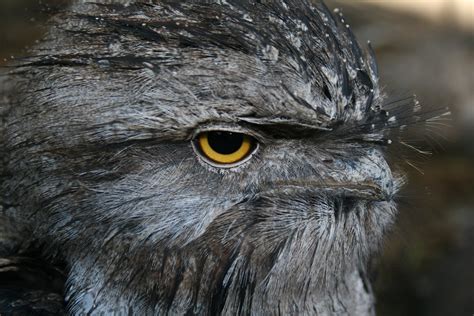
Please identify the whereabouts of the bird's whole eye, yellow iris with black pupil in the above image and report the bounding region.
[195,131,257,167]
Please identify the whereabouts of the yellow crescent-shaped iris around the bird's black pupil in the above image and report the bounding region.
[198,133,252,164]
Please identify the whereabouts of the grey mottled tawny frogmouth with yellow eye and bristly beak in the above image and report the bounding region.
[0,0,434,315]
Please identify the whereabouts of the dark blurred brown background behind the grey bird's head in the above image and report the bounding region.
[0,0,474,316]
